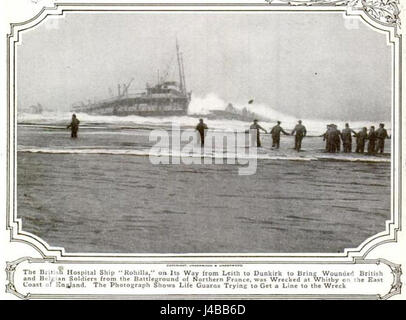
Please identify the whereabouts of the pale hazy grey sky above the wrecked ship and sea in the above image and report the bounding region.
[17,13,392,120]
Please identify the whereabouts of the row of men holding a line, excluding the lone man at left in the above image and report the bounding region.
[196,119,390,154]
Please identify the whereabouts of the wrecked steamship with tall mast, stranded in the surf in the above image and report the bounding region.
[71,43,191,116]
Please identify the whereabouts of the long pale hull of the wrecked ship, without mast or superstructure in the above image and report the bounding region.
[73,97,190,117]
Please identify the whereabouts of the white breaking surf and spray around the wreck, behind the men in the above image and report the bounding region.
[17,94,390,135]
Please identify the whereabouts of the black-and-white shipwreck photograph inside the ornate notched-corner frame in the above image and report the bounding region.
[14,9,394,254]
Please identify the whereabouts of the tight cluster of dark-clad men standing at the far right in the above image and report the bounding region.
[321,123,390,154]
